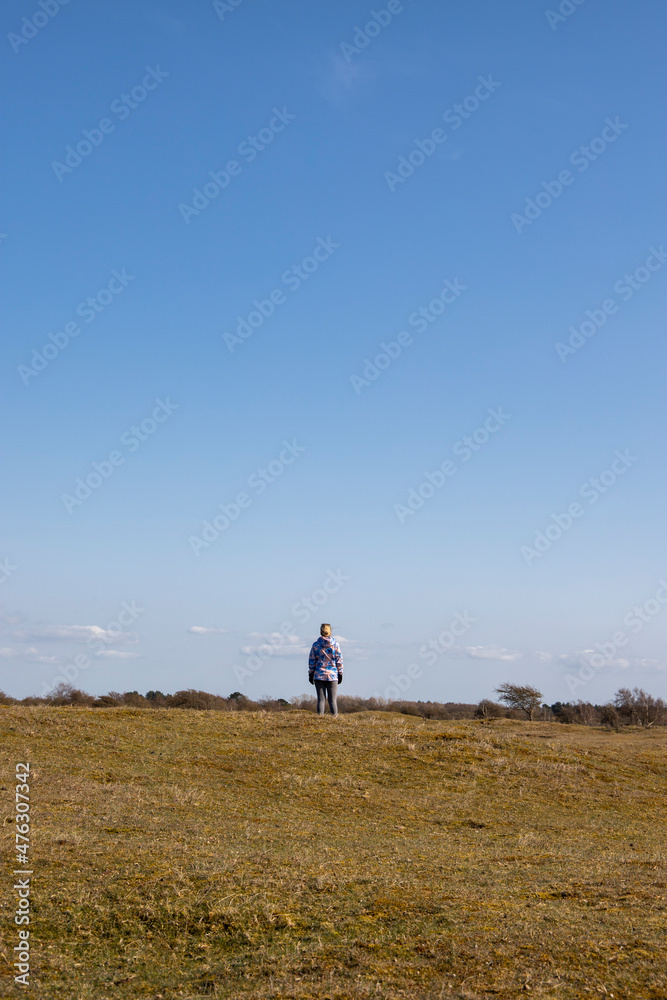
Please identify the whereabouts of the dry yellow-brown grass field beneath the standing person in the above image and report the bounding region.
[0,707,667,1000]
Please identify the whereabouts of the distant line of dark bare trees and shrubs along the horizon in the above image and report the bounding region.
[0,684,667,729]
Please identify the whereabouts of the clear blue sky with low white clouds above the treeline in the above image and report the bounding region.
[0,0,667,702]
